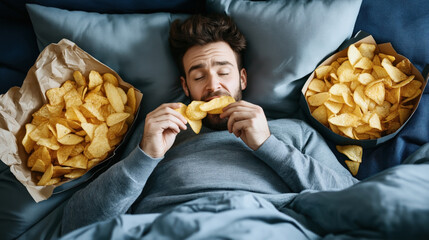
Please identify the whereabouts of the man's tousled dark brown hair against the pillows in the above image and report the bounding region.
[168,14,246,76]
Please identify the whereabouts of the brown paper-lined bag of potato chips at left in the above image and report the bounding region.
[0,39,142,202]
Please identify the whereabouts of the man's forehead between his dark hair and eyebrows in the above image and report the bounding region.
[183,42,237,71]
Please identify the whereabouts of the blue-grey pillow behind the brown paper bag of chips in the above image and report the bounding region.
[27,4,187,116]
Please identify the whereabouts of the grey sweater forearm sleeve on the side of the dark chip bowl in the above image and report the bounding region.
[254,126,358,192]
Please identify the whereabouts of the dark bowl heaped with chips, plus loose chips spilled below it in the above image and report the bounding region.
[300,31,427,175]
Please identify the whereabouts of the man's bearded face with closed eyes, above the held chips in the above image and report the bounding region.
[180,42,247,129]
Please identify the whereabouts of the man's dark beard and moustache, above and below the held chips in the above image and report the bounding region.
[187,85,242,130]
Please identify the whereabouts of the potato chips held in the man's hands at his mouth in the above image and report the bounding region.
[176,96,235,134]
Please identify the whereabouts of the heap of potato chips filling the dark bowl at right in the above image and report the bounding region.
[305,43,423,140]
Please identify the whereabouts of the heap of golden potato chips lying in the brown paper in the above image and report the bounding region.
[22,71,138,186]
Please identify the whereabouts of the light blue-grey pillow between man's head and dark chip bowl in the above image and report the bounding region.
[206,0,362,118]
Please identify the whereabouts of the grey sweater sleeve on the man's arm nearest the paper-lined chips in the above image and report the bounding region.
[62,146,161,234]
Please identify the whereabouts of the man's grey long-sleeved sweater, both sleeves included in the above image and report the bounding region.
[62,119,358,234]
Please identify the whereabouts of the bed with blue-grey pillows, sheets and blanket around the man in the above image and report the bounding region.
[0,0,429,239]
